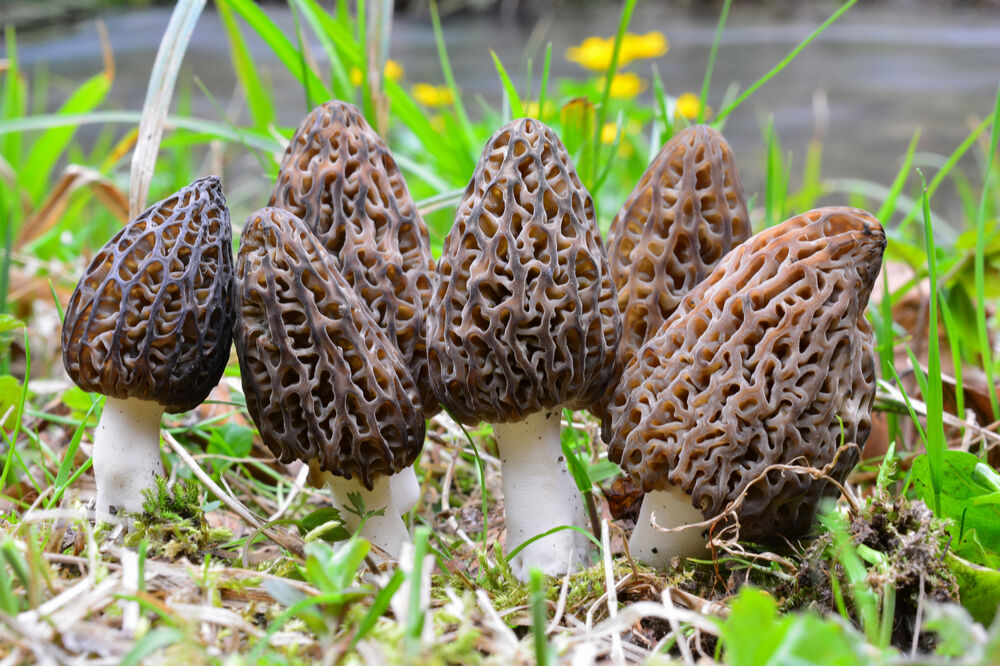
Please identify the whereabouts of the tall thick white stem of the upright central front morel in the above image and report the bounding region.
[493,410,590,581]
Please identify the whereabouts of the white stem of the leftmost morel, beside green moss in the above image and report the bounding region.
[94,396,163,524]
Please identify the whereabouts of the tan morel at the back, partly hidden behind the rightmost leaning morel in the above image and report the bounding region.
[594,125,750,441]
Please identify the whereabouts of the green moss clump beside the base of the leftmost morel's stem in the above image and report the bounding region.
[125,477,232,562]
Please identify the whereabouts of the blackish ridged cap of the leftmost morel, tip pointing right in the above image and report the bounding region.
[62,176,233,412]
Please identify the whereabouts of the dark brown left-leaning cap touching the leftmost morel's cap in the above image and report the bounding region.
[234,208,425,490]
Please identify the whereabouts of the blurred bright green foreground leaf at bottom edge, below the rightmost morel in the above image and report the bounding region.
[719,587,867,665]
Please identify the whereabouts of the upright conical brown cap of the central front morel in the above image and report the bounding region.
[428,119,621,424]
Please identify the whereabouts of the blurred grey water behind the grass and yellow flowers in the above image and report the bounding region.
[11,1,1000,232]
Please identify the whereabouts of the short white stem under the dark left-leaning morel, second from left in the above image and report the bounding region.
[323,472,410,560]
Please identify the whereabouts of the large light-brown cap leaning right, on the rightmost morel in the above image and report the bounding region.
[609,207,886,542]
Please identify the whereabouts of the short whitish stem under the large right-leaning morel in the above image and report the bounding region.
[628,486,708,570]
